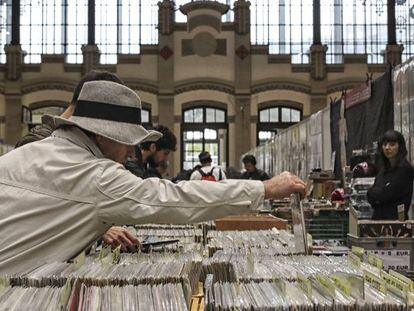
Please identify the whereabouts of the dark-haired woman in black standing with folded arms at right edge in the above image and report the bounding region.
[367,130,414,220]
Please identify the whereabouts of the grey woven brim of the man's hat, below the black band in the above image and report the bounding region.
[54,116,162,146]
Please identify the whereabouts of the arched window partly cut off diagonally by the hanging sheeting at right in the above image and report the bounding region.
[257,106,302,145]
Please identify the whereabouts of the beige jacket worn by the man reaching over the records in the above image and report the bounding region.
[0,127,264,275]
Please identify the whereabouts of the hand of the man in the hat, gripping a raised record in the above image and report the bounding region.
[263,172,306,199]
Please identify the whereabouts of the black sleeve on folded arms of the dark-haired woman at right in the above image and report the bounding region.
[367,166,413,204]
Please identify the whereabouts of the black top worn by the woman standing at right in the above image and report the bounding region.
[367,159,414,220]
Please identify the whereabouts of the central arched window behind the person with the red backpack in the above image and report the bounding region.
[181,107,228,170]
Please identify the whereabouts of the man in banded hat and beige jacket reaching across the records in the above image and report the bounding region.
[0,81,305,274]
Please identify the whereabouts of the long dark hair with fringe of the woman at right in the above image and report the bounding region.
[378,130,408,172]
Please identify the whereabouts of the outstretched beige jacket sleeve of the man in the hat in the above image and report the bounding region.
[96,161,264,225]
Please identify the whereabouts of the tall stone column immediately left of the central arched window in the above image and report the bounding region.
[158,0,174,176]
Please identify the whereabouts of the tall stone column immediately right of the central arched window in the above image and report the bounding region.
[233,0,252,167]
